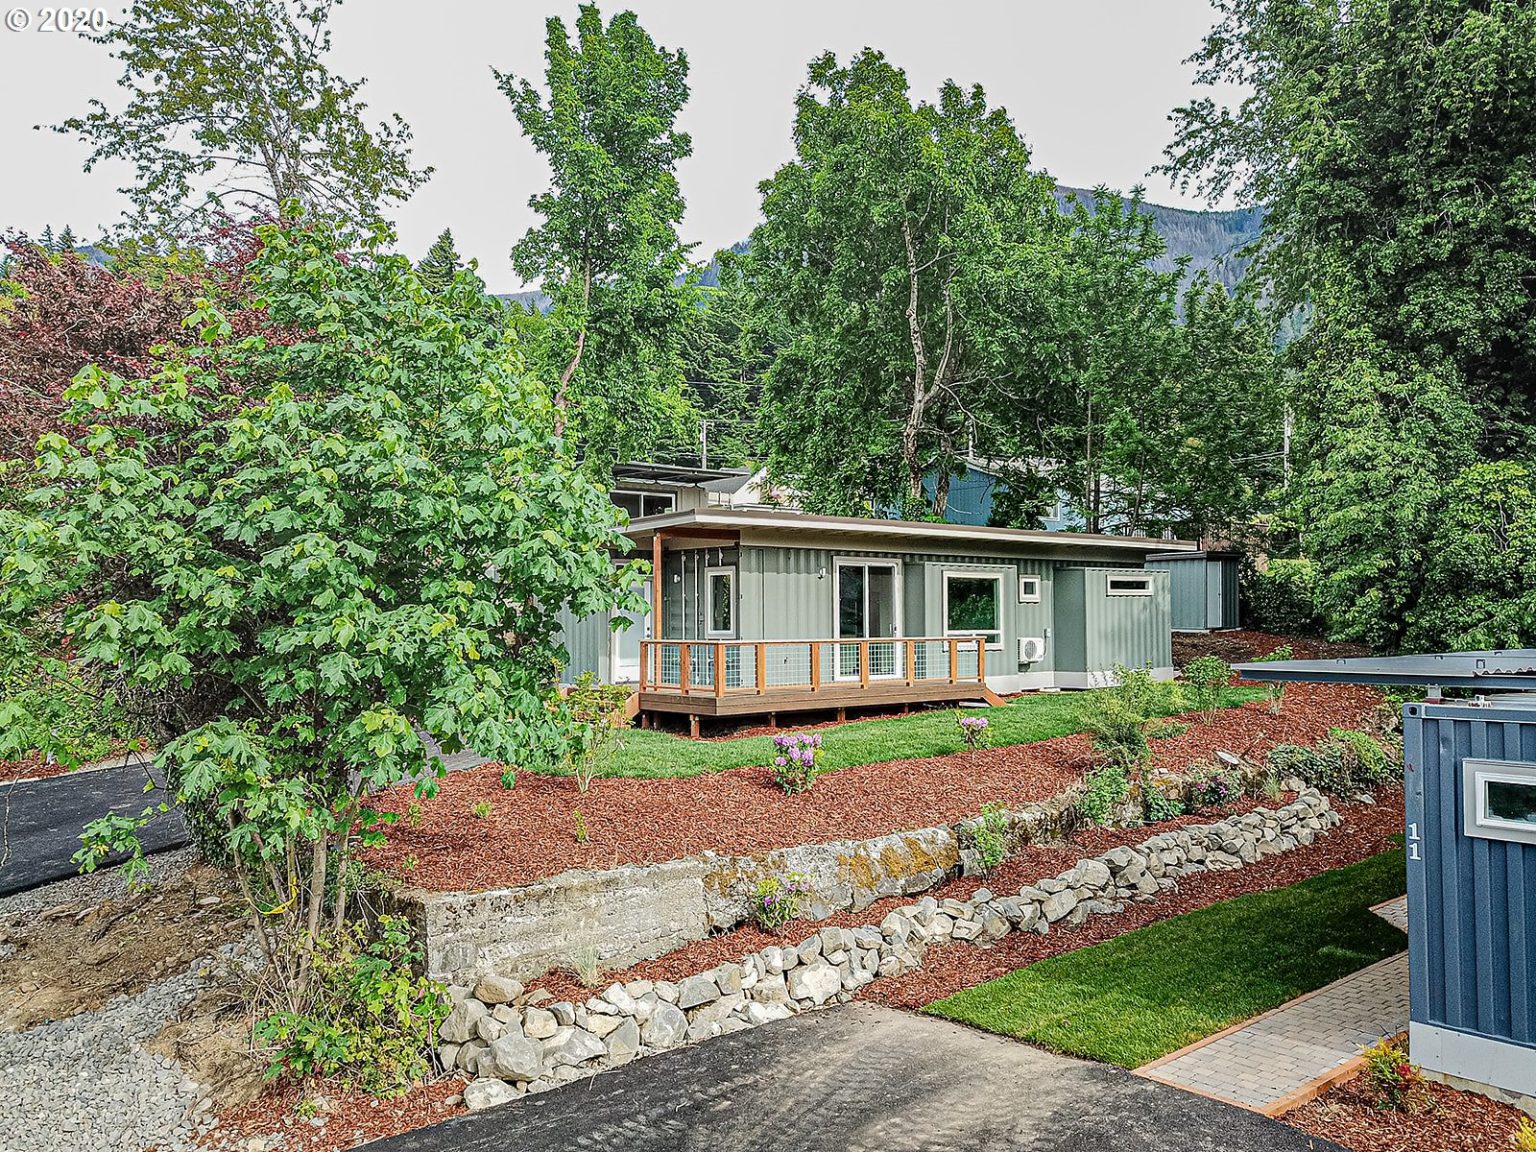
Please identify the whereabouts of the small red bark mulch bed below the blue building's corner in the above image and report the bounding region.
[1281,1077,1525,1152]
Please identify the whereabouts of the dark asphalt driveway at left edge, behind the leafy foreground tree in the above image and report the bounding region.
[0,765,187,895]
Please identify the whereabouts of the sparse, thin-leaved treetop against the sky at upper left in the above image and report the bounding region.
[55,0,432,237]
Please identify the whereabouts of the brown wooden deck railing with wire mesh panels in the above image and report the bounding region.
[641,636,986,696]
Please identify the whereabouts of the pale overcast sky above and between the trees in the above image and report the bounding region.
[0,0,1241,292]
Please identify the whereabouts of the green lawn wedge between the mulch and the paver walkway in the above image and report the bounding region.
[925,849,1407,1068]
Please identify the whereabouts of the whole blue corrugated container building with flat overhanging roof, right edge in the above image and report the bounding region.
[1238,650,1536,1109]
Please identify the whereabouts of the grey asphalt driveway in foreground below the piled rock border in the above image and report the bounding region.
[367,1005,1342,1152]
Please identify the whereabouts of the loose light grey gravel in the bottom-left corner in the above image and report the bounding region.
[0,963,222,1152]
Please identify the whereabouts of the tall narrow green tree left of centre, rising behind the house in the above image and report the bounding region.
[496,5,693,461]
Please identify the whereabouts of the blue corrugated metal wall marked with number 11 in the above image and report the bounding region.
[1402,703,1536,1050]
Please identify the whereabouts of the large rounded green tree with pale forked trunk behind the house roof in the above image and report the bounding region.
[745,49,1058,515]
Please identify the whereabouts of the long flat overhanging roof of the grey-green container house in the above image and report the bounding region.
[627,508,1195,558]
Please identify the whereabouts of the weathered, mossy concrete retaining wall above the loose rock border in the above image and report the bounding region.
[401,791,1077,985]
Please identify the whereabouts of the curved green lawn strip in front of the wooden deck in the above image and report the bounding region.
[562,688,1264,777]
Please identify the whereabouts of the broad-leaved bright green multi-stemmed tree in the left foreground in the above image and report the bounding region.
[0,216,639,1011]
